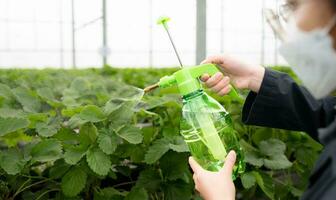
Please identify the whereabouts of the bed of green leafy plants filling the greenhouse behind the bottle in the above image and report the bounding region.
[0,67,321,200]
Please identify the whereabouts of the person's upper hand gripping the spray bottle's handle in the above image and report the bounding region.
[201,55,265,96]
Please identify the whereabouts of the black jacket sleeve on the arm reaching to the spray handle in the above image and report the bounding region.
[242,68,336,139]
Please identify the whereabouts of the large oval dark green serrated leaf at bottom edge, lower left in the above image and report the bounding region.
[61,167,87,197]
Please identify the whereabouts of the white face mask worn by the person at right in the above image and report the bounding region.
[280,16,336,99]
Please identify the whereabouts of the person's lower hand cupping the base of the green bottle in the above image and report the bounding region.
[189,151,236,200]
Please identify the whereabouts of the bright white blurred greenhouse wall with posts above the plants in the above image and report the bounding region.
[0,0,285,68]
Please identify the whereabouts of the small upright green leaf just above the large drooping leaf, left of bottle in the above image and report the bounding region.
[98,130,118,155]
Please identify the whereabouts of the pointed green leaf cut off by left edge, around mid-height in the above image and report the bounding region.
[0,117,29,136]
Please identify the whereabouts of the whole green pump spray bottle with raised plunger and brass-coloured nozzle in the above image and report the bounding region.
[145,18,245,179]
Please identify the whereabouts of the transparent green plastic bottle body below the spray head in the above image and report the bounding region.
[180,89,245,179]
